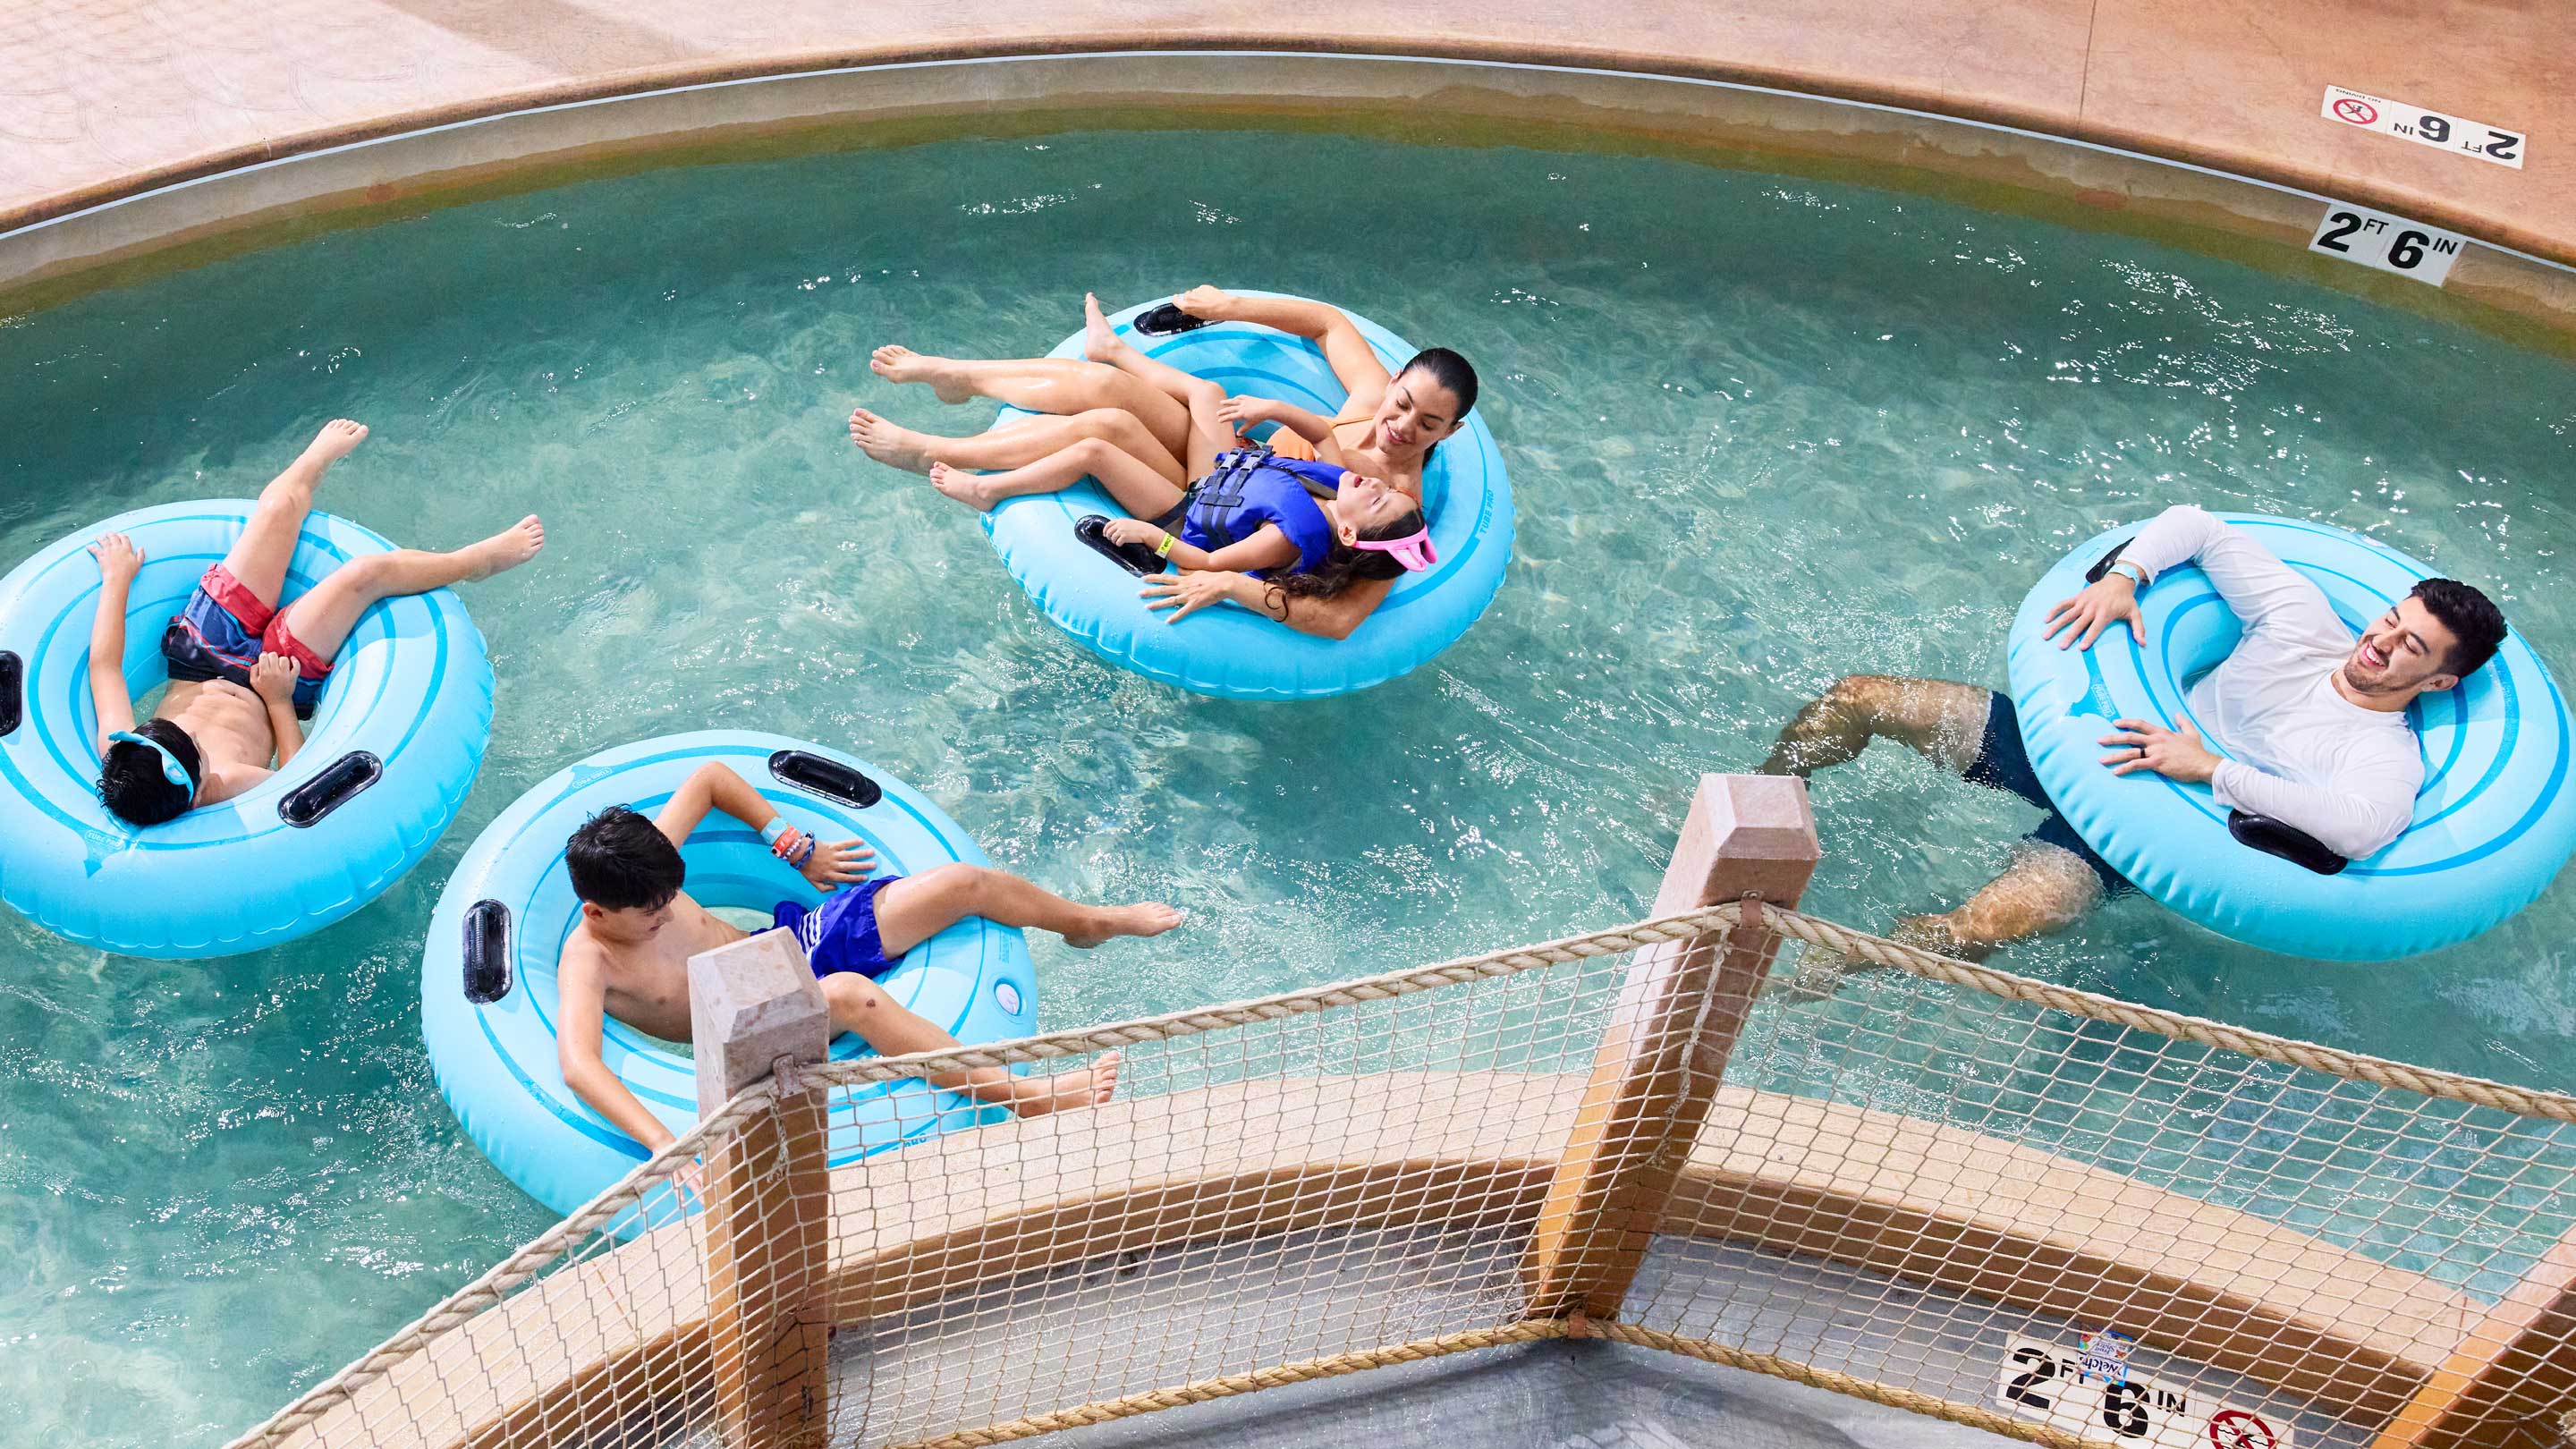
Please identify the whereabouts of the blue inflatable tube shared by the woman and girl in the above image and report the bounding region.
[984,292,1513,699]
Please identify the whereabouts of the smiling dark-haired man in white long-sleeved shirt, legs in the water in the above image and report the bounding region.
[1762,505,2504,959]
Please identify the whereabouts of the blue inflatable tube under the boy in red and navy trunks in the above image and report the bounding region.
[0,500,492,959]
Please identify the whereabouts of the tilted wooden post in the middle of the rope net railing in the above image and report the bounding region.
[1522,776,1821,1318]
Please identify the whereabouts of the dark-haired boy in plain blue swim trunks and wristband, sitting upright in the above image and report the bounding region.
[556,763,1182,1150]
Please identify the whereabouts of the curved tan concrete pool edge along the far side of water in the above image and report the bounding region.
[0,47,2576,353]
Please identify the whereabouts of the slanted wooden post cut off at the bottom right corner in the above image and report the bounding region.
[2370,1230,2576,1449]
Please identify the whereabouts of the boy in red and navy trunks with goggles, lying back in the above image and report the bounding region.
[90,418,547,825]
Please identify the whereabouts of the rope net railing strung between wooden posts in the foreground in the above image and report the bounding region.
[234,905,2576,1449]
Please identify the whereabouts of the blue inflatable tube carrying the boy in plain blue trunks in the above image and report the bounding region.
[419,730,1038,1215]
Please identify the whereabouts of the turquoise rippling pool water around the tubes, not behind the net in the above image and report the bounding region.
[0,134,2576,1444]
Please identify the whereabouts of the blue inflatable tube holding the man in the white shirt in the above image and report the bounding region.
[2007,513,2576,962]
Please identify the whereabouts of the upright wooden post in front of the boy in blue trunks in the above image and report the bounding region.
[688,931,832,1449]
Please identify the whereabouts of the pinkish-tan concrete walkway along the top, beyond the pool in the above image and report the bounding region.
[0,0,2576,263]
